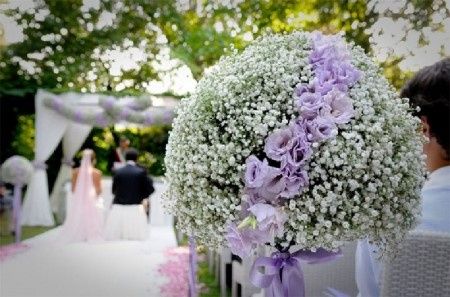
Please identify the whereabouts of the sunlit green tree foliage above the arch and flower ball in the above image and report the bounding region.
[0,0,449,95]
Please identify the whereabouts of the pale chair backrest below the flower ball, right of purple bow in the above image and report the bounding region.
[302,242,358,296]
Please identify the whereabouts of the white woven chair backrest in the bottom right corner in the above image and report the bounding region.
[381,231,450,297]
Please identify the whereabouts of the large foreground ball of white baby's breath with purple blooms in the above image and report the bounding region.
[164,32,424,256]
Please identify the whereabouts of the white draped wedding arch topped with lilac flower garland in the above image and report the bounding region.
[21,90,177,226]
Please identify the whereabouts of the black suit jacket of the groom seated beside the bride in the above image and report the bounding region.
[112,164,155,204]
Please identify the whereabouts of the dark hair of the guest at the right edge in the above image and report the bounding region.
[401,58,450,159]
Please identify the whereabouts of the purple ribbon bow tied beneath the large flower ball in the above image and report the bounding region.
[250,248,342,297]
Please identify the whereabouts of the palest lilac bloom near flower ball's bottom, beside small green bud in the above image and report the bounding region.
[249,203,287,241]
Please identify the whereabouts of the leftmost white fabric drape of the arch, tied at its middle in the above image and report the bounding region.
[22,90,69,226]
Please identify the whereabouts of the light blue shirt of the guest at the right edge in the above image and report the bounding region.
[355,166,450,297]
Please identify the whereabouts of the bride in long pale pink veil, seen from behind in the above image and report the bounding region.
[60,149,103,242]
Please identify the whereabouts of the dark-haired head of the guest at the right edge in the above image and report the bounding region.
[401,58,450,171]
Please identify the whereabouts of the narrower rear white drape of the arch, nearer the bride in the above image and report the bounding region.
[50,123,92,216]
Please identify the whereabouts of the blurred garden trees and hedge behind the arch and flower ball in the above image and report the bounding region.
[0,0,450,185]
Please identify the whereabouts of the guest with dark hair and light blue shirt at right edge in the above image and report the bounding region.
[356,58,450,297]
